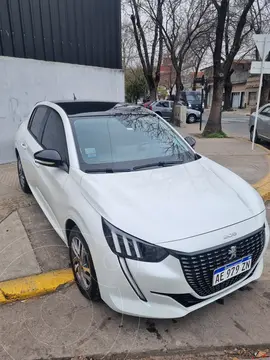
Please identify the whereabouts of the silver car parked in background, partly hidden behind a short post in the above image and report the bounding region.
[148,100,201,124]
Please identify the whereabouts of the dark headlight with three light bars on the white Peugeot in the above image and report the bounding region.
[102,219,169,262]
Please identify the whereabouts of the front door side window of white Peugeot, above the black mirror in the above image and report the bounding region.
[42,109,69,164]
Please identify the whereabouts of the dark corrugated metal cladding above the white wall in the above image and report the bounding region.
[0,0,122,69]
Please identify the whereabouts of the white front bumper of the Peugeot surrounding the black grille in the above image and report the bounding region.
[92,212,269,319]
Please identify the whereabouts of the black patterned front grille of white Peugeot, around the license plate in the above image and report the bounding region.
[174,228,265,296]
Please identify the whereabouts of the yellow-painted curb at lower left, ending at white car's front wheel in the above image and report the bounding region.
[0,269,74,304]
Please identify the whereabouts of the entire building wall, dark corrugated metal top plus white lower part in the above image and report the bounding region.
[0,0,124,163]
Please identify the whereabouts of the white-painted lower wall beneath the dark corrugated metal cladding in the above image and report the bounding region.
[0,57,125,163]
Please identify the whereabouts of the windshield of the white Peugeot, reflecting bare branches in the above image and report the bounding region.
[71,113,196,172]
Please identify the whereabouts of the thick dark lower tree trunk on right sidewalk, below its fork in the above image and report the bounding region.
[203,71,224,136]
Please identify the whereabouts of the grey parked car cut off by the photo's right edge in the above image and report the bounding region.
[249,104,270,142]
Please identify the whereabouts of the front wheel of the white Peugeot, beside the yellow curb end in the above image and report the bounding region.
[68,226,100,301]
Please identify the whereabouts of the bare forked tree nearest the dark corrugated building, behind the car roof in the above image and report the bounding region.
[128,0,164,100]
